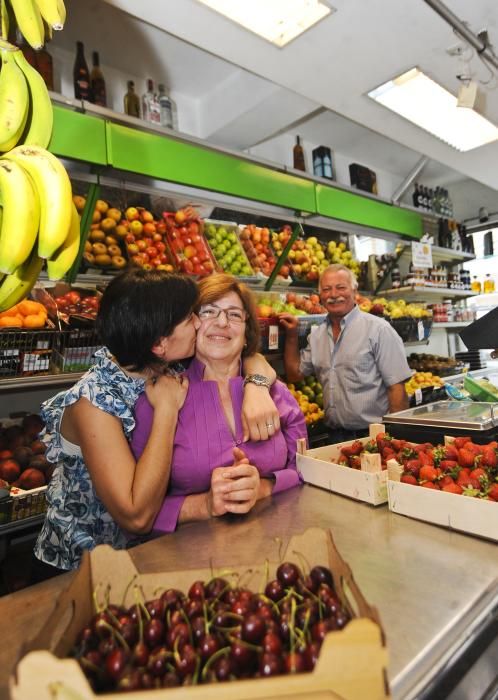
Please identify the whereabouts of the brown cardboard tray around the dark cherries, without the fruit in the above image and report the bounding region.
[10,528,389,700]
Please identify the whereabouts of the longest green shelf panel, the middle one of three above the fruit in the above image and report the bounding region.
[107,122,315,212]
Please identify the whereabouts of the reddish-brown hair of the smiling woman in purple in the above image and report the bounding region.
[195,272,260,357]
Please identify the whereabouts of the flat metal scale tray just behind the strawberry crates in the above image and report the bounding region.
[383,401,498,431]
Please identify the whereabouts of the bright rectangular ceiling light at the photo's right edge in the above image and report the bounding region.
[368,68,498,151]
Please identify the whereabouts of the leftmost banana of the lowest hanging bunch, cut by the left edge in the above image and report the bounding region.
[0,160,40,274]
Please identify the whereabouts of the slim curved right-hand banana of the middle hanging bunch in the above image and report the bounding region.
[14,51,54,148]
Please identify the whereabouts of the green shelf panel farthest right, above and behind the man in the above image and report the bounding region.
[316,184,423,240]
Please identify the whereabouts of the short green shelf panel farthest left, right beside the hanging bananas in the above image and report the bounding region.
[49,105,108,165]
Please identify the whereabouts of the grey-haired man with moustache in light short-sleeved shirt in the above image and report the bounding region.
[279,265,412,442]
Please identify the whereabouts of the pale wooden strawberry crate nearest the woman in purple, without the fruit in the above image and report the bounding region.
[296,423,387,506]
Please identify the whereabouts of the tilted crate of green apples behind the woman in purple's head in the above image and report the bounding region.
[204,219,254,277]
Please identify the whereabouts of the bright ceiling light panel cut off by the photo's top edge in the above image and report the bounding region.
[198,0,335,48]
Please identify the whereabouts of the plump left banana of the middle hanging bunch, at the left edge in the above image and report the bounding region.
[0,49,29,151]
